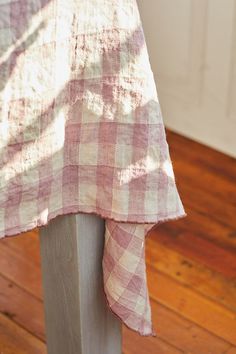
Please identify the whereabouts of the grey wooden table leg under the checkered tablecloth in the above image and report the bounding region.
[39,213,122,354]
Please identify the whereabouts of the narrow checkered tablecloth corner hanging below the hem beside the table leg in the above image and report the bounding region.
[102,220,156,336]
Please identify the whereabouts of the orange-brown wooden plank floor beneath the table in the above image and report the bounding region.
[0,130,236,354]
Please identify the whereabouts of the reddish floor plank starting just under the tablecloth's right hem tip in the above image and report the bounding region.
[148,226,236,279]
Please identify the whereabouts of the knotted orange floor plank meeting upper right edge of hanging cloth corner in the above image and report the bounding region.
[145,238,236,313]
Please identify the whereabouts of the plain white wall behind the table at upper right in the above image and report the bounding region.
[137,0,236,157]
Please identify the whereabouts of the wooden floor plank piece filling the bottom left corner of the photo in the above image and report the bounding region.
[0,313,47,354]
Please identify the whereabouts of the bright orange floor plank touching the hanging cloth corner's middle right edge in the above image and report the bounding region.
[147,264,236,345]
